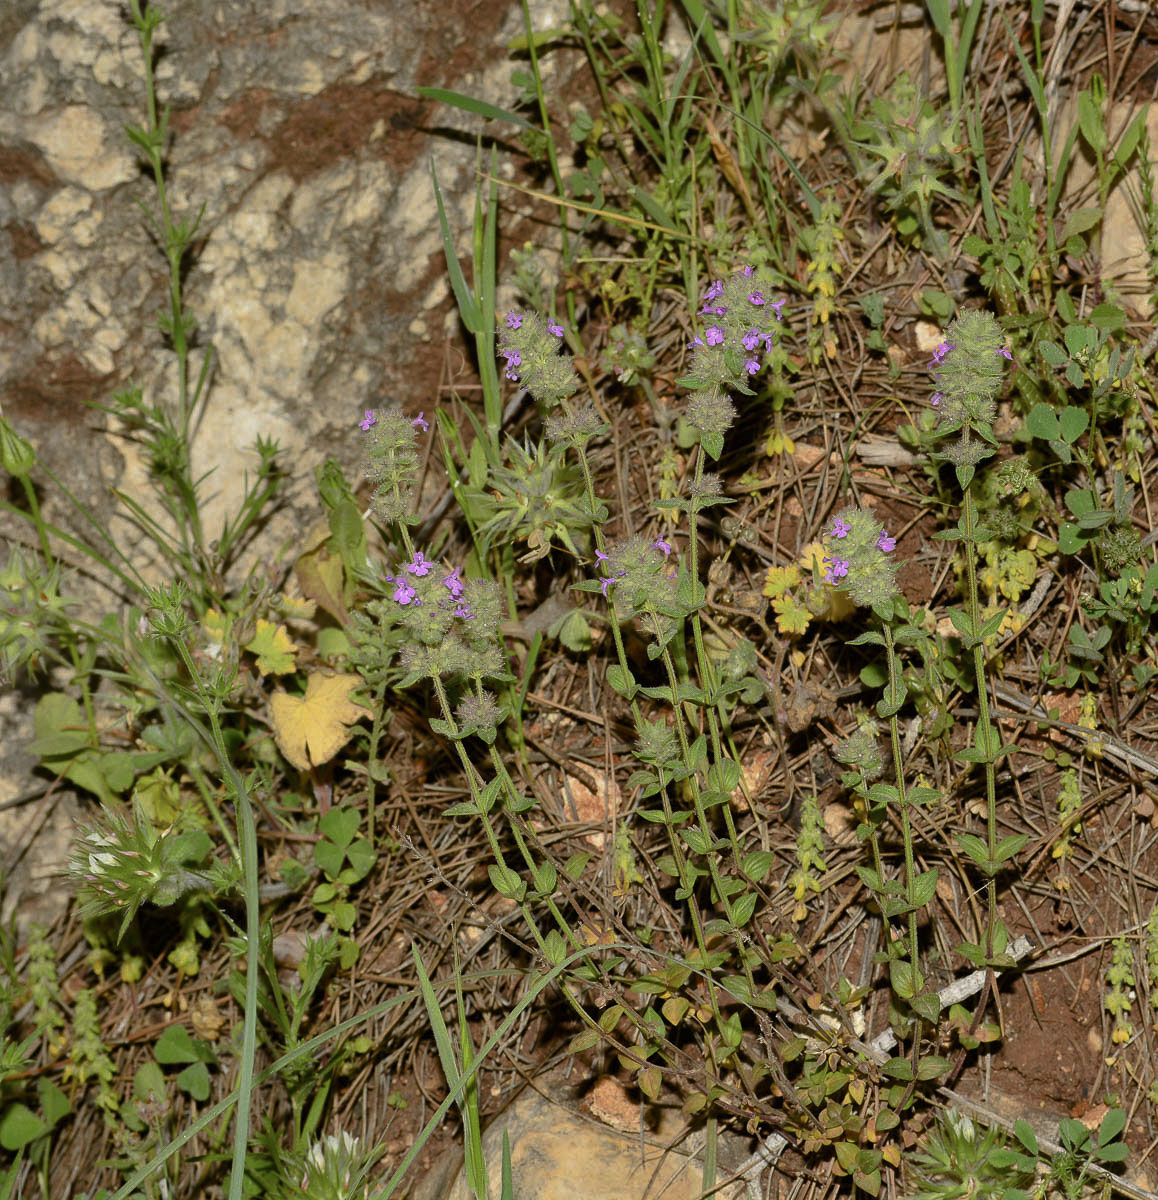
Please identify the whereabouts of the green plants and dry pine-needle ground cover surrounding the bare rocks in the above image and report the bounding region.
[0,0,1158,1200]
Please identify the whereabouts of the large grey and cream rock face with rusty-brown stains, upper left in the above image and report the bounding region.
[0,0,566,919]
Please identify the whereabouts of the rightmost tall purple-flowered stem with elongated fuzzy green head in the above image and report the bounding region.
[929,312,1027,966]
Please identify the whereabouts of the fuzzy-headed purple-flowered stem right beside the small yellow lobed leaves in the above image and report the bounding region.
[823,508,949,1079]
